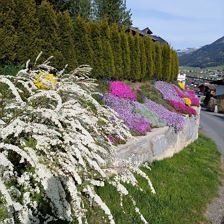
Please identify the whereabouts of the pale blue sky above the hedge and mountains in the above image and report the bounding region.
[126,0,224,49]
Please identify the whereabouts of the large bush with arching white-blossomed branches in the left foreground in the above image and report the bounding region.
[0,53,155,223]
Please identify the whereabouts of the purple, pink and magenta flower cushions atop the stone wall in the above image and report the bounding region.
[104,81,193,134]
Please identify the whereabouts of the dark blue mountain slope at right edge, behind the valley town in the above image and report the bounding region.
[179,36,224,68]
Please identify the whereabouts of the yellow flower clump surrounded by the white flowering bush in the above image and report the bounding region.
[33,72,57,90]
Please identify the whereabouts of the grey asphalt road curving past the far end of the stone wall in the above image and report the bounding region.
[200,109,224,156]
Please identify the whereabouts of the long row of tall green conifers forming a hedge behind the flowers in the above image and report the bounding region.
[0,0,178,81]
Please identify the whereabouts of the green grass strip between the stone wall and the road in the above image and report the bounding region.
[95,135,222,224]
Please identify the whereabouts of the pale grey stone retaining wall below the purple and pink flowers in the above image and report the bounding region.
[115,108,200,167]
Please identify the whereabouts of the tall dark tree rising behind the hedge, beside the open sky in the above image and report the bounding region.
[93,0,132,27]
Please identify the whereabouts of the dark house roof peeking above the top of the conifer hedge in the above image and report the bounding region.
[126,27,168,44]
